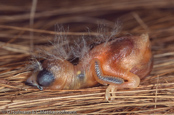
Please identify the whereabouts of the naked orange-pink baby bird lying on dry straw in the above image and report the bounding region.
[26,34,153,101]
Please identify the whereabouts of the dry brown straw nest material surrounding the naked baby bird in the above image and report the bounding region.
[0,0,174,114]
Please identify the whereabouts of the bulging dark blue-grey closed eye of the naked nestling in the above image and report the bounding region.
[37,69,54,86]
